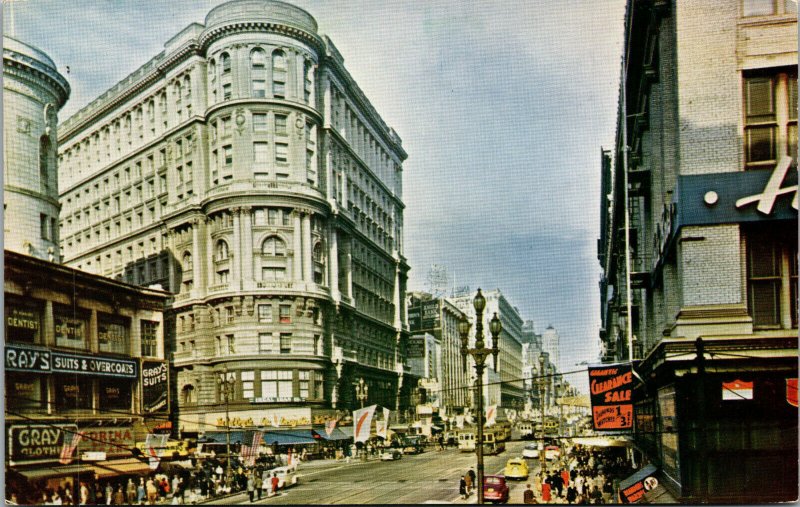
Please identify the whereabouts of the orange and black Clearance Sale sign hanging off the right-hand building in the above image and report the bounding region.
[589,364,633,431]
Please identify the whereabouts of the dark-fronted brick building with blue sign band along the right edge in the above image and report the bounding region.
[598,0,798,503]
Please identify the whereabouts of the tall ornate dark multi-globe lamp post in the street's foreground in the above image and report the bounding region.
[458,289,503,504]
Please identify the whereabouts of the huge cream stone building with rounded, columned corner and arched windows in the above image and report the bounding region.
[59,0,408,433]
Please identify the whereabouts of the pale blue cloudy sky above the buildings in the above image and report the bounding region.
[3,0,625,386]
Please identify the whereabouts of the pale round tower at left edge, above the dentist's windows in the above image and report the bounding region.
[3,35,70,262]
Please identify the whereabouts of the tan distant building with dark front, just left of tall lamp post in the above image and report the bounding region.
[406,292,471,415]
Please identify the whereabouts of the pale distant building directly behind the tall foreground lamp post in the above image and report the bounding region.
[451,289,525,414]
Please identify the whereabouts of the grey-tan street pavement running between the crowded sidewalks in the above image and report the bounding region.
[203,442,538,505]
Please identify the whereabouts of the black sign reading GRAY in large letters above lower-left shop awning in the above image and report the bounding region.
[8,424,78,463]
